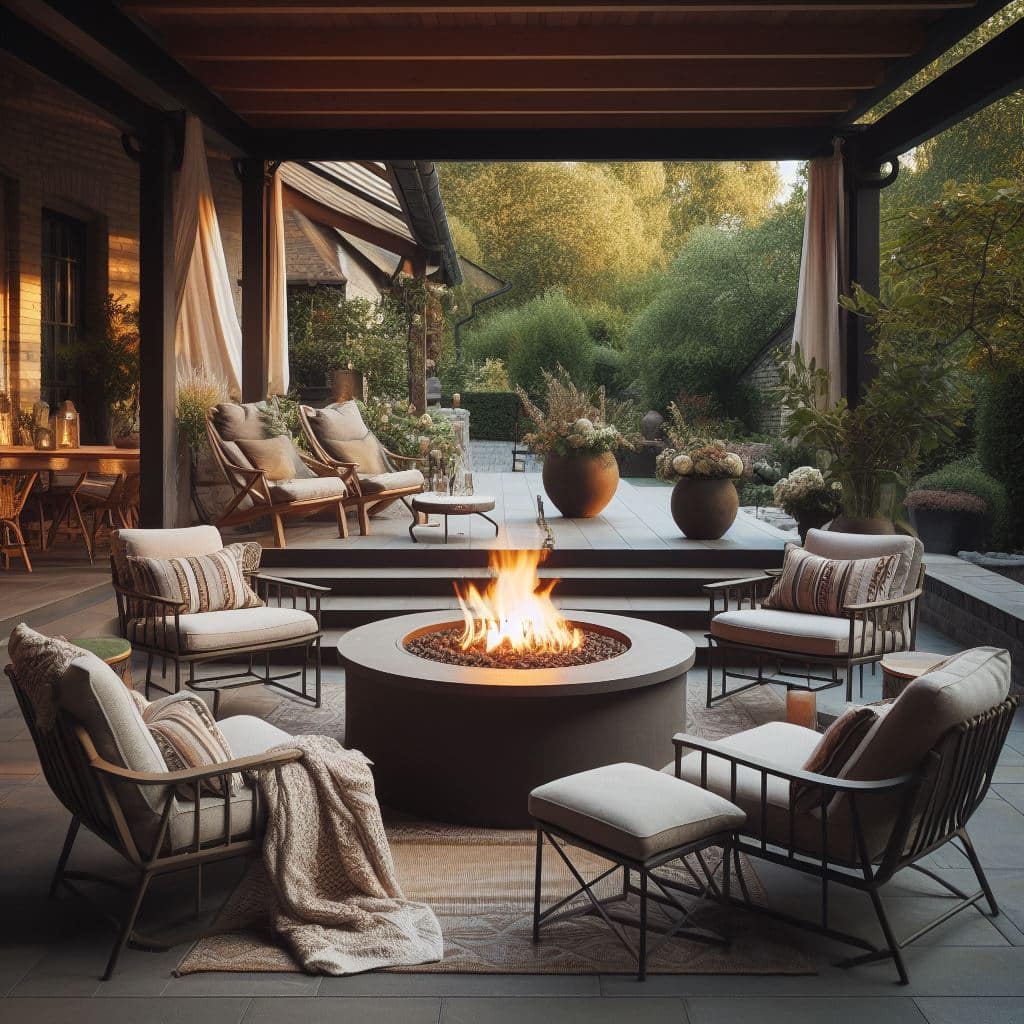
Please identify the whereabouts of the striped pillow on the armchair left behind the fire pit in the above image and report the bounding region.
[128,545,263,614]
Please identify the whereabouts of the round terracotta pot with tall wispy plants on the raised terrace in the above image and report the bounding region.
[517,367,636,519]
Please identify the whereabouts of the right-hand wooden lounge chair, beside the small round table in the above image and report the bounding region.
[299,400,425,537]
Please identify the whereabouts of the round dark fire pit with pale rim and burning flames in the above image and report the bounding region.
[338,552,694,827]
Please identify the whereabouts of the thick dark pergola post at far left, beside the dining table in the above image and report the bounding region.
[138,115,178,528]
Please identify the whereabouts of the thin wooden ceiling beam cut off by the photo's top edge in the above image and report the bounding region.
[122,0,975,15]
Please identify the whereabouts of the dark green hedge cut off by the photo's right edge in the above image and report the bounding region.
[975,373,1024,548]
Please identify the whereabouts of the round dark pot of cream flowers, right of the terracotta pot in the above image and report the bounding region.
[656,441,743,541]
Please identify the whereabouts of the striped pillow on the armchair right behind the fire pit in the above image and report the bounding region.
[761,547,899,616]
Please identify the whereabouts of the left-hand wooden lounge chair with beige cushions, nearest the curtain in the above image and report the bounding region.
[206,402,348,548]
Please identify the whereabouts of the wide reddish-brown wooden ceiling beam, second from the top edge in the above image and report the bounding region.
[164,25,922,59]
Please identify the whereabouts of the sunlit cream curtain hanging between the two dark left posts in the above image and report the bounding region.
[174,115,242,396]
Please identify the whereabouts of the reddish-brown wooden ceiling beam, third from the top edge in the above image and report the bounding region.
[197,58,885,95]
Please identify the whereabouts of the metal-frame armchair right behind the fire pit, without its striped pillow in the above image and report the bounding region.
[703,530,925,708]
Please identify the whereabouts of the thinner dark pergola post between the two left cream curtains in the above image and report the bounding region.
[241,159,268,401]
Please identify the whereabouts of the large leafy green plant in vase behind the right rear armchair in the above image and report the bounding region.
[778,339,969,534]
